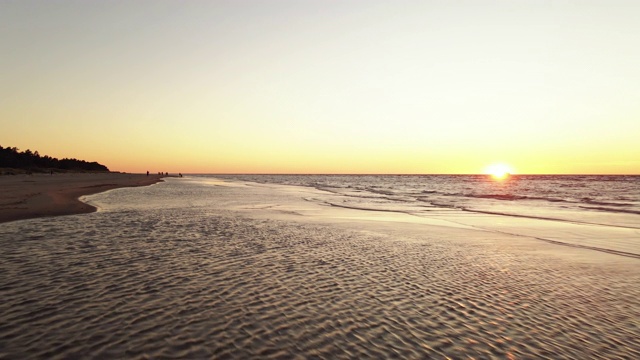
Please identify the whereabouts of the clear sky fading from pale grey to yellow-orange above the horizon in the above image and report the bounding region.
[0,0,640,174]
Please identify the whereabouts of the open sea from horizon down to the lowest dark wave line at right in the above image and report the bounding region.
[218,175,640,257]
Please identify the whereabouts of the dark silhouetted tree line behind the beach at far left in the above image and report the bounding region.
[0,146,109,172]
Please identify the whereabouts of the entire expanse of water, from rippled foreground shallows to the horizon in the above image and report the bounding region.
[0,175,640,359]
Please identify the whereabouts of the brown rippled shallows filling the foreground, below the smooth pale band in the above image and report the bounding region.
[0,182,640,359]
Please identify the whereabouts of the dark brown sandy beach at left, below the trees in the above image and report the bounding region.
[0,173,165,224]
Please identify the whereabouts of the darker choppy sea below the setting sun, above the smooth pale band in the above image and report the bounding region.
[215,175,640,229]
